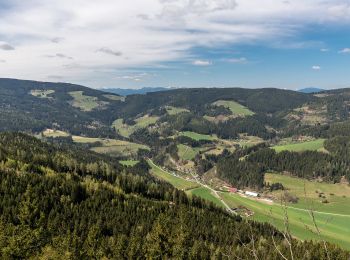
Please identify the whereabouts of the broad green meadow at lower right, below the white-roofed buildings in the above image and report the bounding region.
[221,173,350,249]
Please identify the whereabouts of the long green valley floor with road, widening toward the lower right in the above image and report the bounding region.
[149,160,350,249]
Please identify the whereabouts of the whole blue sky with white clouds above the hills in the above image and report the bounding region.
[0,0,350,89]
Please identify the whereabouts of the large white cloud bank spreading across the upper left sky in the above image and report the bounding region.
[0,0,350,86]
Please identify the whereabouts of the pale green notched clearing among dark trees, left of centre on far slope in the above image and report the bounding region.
[112,115,159,137]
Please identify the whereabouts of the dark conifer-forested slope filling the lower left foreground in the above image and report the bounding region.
[0,133,349,259]
